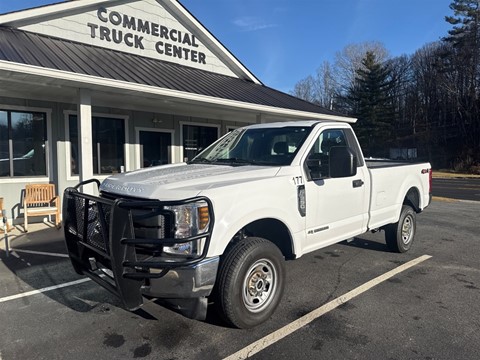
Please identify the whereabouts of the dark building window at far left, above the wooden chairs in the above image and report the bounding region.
[0,110,47,177]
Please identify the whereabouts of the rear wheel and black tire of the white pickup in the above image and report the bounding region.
[385,205,417,253]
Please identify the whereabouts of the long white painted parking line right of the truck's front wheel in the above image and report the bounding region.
[224,255,431,360]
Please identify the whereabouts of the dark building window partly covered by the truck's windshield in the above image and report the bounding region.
[182,125,218,161]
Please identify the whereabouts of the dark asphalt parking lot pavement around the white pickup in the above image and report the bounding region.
[0,202,480,360]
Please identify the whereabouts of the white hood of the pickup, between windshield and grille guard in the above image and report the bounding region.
[100,163,280,200]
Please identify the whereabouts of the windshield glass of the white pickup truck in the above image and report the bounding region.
[190,126,312,166]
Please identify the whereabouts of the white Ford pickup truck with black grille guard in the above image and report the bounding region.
[63,121,431,328]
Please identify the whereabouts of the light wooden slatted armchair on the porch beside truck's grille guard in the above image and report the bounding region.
[23,184,61,232]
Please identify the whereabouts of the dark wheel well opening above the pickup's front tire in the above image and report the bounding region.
[237,219,295,260]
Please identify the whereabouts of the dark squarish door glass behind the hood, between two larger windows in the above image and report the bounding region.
[139,130,172,168]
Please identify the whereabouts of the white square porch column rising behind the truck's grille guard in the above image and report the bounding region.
[77,89,96,194]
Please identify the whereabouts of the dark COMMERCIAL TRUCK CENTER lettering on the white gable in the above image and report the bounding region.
[87,7,207,65]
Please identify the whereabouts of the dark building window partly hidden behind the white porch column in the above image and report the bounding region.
[69,115,125,175]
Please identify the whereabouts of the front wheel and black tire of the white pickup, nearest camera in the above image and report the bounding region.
[215,237,285,329]
